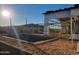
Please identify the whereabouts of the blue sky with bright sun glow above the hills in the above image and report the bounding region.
[0,4,73,26]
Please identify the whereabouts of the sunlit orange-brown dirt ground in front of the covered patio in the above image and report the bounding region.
[37,39,78,55]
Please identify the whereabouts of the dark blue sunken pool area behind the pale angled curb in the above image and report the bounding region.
[6,34,54,42]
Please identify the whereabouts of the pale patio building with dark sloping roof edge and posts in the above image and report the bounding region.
[43,4,79,42]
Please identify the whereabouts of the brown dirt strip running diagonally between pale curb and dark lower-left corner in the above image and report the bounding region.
[0,36,48,55]
